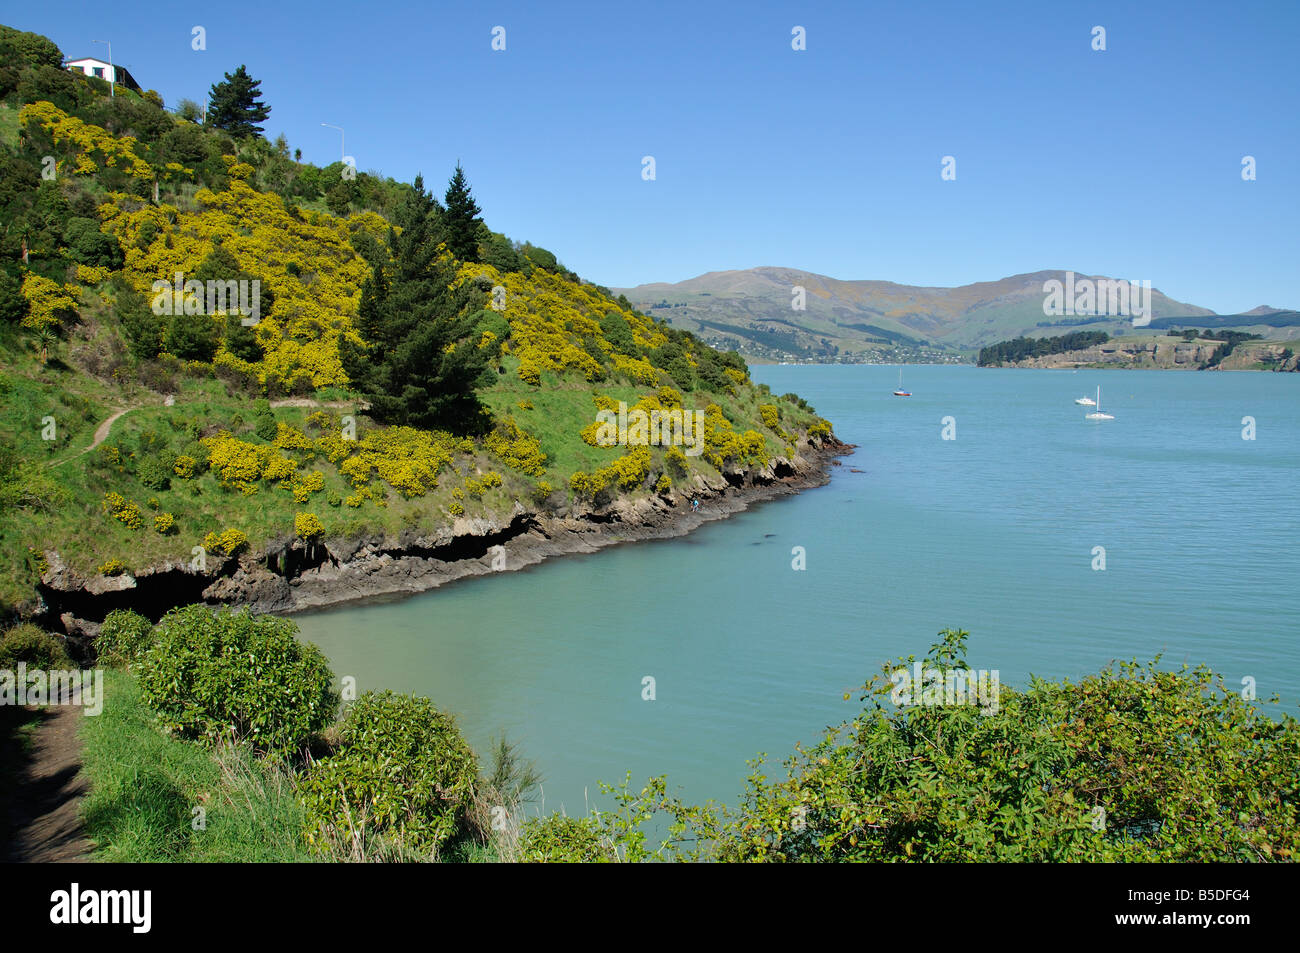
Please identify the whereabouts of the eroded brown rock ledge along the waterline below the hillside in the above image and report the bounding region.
[36,437,853,647]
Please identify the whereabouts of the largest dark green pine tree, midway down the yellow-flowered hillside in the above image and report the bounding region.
[339,176,491,433]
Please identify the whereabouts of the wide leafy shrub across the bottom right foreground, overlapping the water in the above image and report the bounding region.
[520,629,1300,862]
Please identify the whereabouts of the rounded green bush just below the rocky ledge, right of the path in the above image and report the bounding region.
[139,606,338,754]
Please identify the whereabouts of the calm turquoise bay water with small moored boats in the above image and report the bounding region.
[295,367,1300,814]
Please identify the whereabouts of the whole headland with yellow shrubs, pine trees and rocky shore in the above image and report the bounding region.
[0,20,840,634]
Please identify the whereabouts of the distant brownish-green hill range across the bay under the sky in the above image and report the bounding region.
[615,268,1294,361]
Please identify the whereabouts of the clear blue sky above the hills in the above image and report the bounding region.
[12,0,1300,312]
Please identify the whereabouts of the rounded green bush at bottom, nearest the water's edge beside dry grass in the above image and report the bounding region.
[302,692,478,854]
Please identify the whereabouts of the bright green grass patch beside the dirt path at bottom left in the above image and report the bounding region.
[82,670,316,863]
